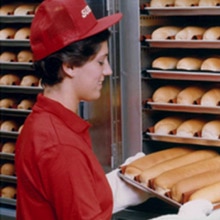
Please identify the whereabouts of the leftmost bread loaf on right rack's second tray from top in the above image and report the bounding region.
[151,26,181,40]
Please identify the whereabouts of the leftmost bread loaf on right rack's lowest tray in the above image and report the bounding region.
[154,116,184,135]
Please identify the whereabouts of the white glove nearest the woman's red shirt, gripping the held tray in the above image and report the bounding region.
[106,153,151,213]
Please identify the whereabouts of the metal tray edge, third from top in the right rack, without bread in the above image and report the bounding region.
[144,69,220,82]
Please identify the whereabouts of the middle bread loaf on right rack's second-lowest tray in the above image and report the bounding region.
[176,86,206,105]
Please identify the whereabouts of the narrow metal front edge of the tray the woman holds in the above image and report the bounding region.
[118,171,182,207]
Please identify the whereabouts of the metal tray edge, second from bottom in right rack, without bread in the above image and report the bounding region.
[147,102,220,115]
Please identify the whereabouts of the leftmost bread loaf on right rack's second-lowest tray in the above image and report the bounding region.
[152,85,182,103]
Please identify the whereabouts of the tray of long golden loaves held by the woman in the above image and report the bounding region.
[118,147,220,207]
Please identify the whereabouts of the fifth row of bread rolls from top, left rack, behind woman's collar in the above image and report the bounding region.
[0,98,35,110]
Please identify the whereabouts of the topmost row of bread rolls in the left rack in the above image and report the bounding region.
[0,3,39,16]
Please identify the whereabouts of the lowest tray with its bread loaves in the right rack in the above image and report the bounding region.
[146,116,220,147]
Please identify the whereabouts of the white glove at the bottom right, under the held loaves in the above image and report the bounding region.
[151,199,214,220]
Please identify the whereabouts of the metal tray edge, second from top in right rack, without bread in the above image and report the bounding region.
[144,39,220,49]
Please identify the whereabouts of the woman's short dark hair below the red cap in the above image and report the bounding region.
[35,30,110,85]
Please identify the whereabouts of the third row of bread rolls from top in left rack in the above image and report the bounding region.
[0,49,34,62]
